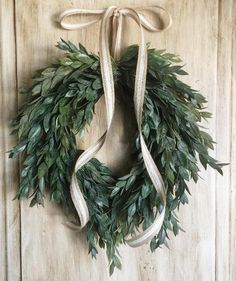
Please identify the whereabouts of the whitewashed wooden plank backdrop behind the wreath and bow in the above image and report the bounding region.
[0,0,236,281]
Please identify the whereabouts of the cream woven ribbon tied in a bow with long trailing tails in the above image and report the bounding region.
[59,6,172,247]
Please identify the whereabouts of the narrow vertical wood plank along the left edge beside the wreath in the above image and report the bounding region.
[0,0,21,281]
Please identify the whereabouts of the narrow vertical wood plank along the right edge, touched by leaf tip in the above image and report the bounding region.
[215,0,235,281]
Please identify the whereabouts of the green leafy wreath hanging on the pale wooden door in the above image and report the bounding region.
[10,40,223,273]
